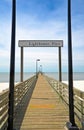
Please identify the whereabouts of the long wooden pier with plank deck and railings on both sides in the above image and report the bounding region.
[0,74,84,130]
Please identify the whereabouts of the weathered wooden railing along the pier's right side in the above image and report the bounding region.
[45,76,84,129]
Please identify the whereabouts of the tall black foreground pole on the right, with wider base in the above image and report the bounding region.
[68,0,75,126]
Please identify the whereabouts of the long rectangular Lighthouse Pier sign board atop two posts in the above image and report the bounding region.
[18,40,63,47]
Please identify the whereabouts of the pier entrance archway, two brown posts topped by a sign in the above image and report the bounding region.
[18,40,63,82]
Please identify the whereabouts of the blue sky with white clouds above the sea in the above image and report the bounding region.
[0,0,84,72]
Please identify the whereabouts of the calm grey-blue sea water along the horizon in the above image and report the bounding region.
[0,72,84,83]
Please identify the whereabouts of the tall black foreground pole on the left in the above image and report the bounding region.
[7,0,16,130]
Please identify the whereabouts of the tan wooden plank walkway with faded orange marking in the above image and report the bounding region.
[15,75,68,130]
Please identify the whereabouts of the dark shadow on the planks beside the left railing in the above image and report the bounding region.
[14,80,36,130]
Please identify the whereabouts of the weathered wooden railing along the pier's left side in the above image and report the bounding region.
[0,76,36,130]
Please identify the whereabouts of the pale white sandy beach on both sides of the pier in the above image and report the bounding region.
[0,80,84,93]
